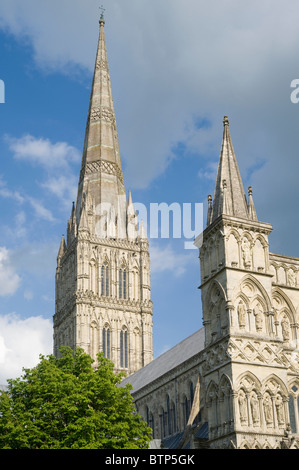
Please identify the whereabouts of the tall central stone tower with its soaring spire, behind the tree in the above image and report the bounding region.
[54,15,153,374]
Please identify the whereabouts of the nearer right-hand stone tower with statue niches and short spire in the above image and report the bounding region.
[200,116,299,448]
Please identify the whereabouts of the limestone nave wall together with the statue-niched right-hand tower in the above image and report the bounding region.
[124,117,299,449]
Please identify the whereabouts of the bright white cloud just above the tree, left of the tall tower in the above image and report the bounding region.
[0,314,53,385]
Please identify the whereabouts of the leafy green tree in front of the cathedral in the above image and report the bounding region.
[0,347,151,449]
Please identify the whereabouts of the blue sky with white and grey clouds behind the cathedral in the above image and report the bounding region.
[0,0,299,384]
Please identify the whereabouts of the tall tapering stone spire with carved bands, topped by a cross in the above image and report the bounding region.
[76,14,126,229]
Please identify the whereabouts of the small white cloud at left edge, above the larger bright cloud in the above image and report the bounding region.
[0,246,21,297]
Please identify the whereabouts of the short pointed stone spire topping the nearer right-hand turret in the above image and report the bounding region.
[207,116,257,225]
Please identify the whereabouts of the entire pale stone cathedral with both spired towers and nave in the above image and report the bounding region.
[54,15,299,449]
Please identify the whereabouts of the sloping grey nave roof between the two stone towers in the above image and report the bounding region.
[121,328,204,393]
